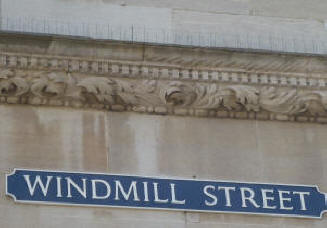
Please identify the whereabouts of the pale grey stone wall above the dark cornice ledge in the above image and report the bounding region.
[1,0,327,54]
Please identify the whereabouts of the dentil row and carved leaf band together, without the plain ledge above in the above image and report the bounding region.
[0,52,327,123]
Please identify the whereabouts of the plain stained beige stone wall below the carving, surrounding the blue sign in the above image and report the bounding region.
[0,105,327,228]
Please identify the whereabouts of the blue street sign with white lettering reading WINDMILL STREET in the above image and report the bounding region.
[6,169,327,218]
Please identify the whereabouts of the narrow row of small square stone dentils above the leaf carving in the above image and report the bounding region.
[0,53,327,89]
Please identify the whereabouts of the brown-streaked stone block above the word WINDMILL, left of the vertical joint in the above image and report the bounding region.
[0,105,108,172]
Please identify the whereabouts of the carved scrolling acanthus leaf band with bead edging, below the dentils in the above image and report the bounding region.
[0,67,327,122]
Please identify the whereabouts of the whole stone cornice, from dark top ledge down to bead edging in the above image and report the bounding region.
[0,32,327,123]
